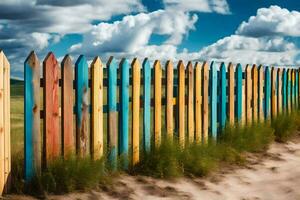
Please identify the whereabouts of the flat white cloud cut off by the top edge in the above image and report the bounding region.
[163,0,230,14]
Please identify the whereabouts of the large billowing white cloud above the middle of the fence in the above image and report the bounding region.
[70,10,198,54]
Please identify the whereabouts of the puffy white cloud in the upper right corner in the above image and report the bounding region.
[236,6,300,37]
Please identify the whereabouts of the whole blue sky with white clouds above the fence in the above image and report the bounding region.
[0,0,300,77]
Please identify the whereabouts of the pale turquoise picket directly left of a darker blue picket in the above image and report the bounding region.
[210,62,218,139]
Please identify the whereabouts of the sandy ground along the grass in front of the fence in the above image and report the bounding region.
[6,138,300,200]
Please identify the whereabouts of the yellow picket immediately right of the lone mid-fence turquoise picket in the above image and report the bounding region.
[153,60,162,147]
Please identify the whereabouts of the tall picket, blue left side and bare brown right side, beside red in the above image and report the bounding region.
[24,52,42,183]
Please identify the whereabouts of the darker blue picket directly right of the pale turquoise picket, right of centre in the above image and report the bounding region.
[219,63,227,129]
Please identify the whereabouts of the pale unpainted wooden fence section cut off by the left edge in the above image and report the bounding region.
[0,50,11,196]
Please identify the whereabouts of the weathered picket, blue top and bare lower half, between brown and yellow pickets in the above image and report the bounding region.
[75,55,89,157]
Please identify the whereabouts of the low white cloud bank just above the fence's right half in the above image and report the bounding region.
[199,35,299,65]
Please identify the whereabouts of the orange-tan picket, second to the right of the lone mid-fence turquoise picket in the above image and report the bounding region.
[166,60,174,141]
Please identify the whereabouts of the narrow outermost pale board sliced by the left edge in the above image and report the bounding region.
[0,51,6,196]
